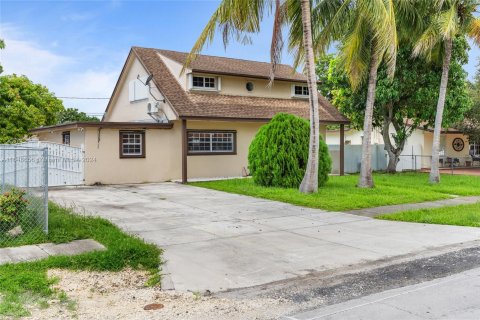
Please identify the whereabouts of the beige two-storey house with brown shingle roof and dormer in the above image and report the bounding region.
[32,47,349,184]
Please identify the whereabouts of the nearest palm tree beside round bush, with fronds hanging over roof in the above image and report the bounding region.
[184,0,320,193]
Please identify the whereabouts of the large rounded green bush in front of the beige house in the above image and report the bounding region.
[248,113,332,188]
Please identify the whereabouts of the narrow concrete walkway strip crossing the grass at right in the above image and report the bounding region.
[346,196,480,218]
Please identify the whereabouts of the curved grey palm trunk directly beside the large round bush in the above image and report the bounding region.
[299,0,320,193]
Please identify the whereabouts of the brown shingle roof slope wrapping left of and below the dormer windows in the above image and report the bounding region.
[132,47,349,123]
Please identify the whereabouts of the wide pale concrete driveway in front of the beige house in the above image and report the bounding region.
[50,183,480,291]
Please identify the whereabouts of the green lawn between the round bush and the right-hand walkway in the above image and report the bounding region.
[190,173,480,211]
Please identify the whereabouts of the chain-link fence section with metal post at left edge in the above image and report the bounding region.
[0,145,48,247]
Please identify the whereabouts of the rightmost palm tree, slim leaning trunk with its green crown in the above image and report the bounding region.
[413,0,480,183]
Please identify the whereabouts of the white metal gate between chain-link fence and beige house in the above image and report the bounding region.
[15,140,85,187]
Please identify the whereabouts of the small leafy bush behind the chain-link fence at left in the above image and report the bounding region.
[0,189,28,226]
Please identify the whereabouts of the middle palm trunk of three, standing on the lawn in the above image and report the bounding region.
[358,50,378,188]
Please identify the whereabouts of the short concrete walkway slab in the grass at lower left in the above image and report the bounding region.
[0,239,105,264]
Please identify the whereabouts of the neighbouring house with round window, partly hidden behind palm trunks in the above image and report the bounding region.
[325,126,474,172]
